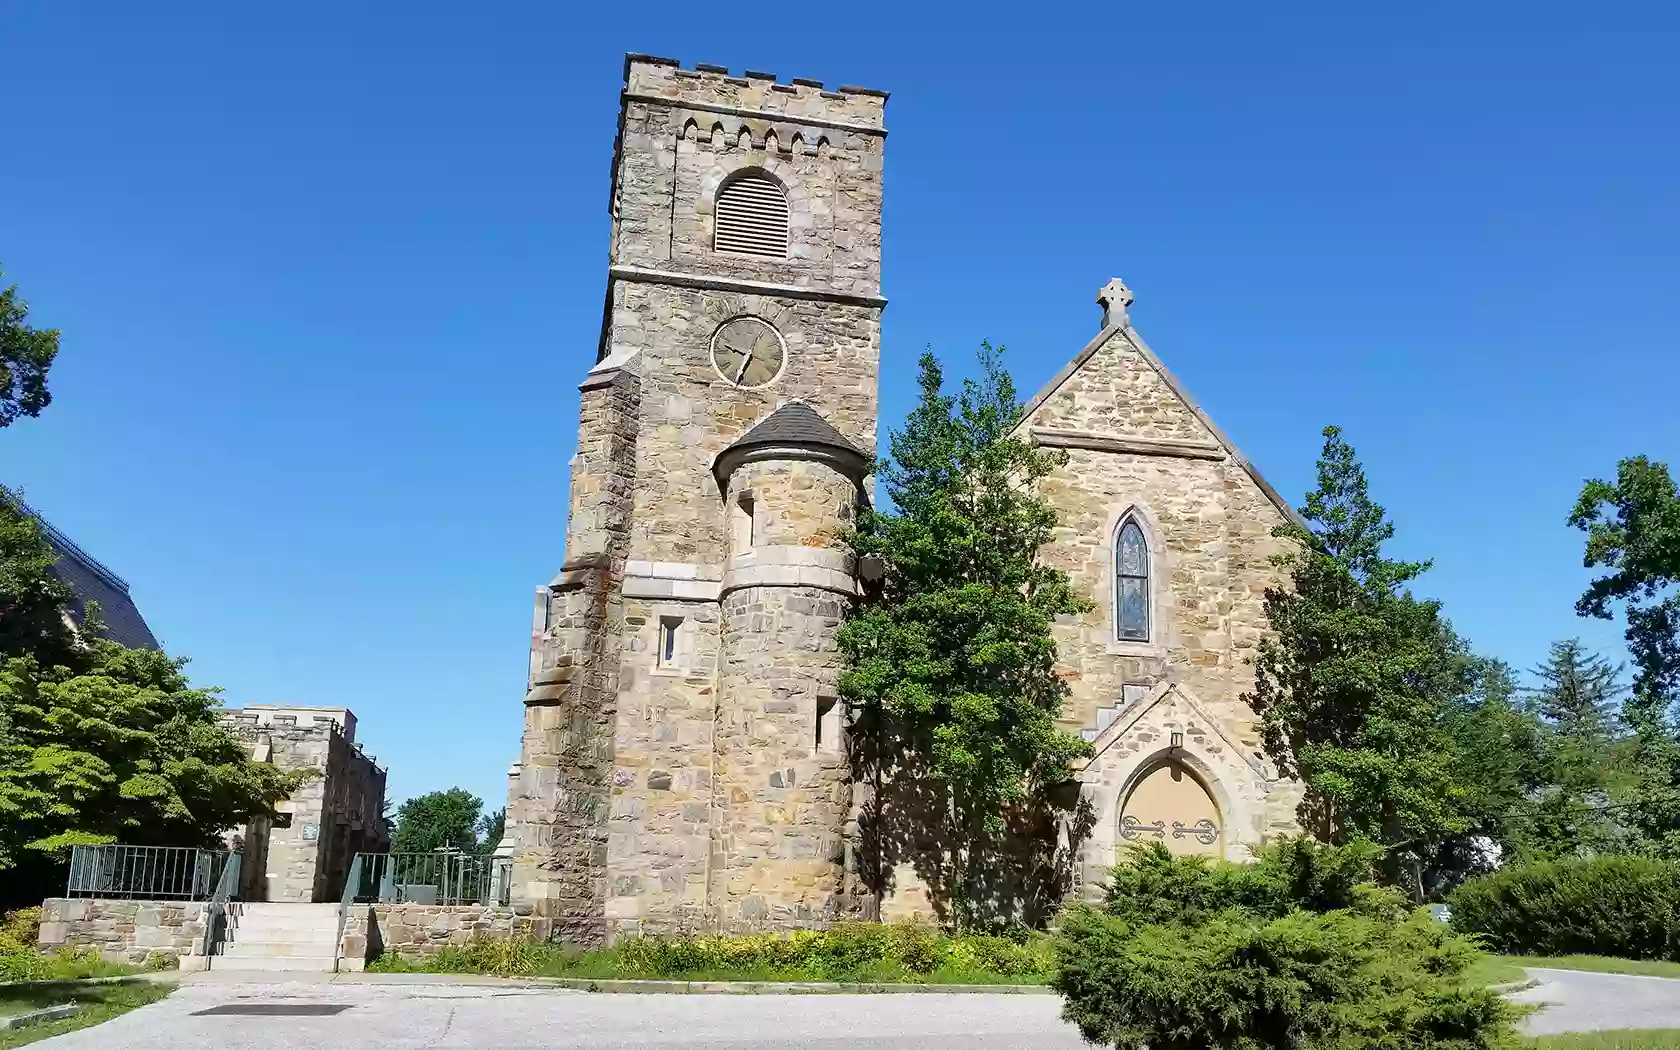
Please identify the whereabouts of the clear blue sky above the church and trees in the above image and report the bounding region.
[0,0,1680,806]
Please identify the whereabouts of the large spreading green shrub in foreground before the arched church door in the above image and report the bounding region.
[1052,840,1515,1050]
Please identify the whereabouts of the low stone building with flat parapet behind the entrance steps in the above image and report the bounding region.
[222,704,391,904]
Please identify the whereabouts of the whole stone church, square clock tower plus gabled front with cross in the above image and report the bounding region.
[504,55,1294,942]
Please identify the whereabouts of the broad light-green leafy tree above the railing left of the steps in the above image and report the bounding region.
[0,638,302,867]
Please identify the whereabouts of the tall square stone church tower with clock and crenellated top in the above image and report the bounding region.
[507,55,887,942]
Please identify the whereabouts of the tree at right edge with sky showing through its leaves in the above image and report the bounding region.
[1569,455,1680,858]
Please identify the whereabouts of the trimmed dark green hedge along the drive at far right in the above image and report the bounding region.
[1448,857,1680,959]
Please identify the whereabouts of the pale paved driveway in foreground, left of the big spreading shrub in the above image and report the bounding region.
[39,981,1087,1050]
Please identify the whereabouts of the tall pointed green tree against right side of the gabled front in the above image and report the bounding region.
[1245,427,1472,892]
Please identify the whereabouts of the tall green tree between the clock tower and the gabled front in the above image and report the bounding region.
[838,344,1089,921]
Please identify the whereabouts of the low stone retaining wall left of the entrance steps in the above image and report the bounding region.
[39,897,205,969]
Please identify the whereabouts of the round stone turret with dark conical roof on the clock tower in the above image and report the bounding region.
[707,403,867,929]
